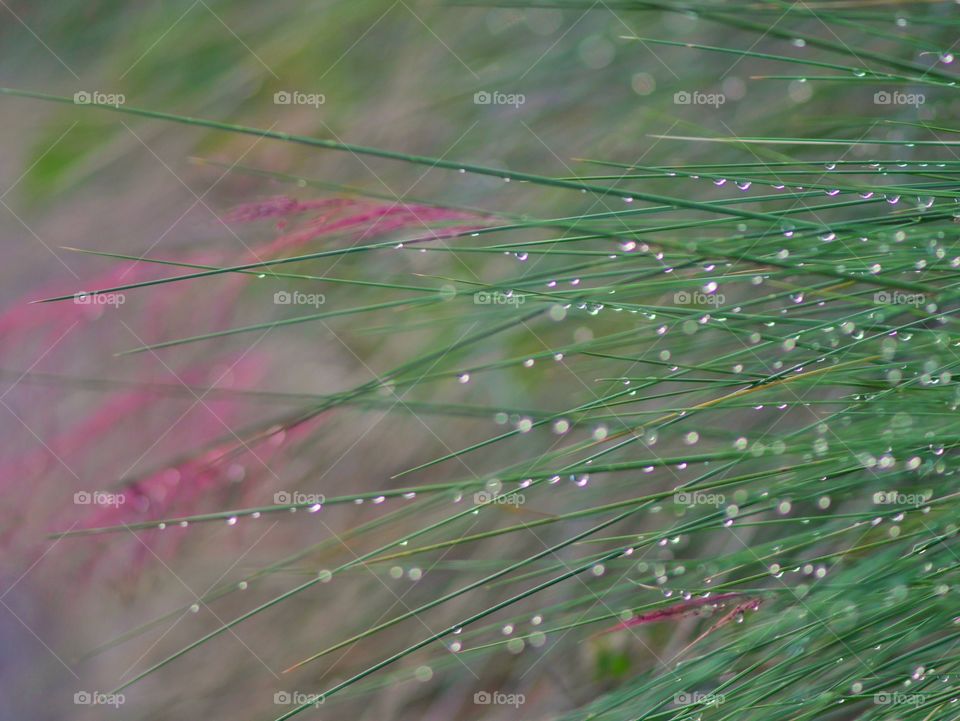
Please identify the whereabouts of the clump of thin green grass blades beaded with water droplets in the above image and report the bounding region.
[0,0,960,719]
